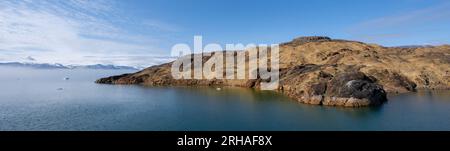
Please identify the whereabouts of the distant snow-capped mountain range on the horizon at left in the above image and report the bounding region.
[0,62,141,70]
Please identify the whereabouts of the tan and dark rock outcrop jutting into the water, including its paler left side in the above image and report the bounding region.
[283,69,387,107]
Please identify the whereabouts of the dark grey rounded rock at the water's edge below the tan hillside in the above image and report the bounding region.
[326,72,387,106]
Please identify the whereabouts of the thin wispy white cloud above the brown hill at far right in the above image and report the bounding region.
[348,2,450,44]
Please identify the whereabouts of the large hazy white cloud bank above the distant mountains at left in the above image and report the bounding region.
[0,0,172,65]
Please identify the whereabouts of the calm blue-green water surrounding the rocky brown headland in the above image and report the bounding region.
[0,67,450,130]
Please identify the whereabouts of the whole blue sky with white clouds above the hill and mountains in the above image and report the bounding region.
[0,0,450,67]
